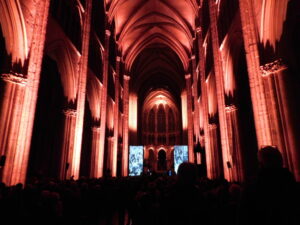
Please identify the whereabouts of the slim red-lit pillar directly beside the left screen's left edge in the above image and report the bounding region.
[122,75,130,176]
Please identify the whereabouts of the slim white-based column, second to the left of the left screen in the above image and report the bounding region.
[111,56,121,177]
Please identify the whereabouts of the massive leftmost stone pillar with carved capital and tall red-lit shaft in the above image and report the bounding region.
[0,0,50,185]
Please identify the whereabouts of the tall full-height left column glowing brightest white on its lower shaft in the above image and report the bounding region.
[71,0,92,179]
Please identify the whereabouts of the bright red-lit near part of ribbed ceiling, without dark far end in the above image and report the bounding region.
[108,0,198,69]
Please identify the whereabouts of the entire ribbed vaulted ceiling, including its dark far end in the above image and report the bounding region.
[107,0,198,112]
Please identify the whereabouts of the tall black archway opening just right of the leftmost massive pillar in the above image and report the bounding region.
[28,56,65,178]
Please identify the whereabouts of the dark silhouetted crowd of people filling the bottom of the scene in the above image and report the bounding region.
[0,149,300,225]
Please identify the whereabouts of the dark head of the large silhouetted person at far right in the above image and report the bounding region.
[258,146,283,169]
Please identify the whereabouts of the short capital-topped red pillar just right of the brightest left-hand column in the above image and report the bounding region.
[90,126,100,178]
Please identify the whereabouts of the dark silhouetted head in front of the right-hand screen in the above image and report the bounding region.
[178,162,197,184]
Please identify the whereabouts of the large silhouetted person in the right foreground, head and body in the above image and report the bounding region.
[239,146,299,225]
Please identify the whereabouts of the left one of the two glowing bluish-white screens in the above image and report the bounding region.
[129,146,144,176]
